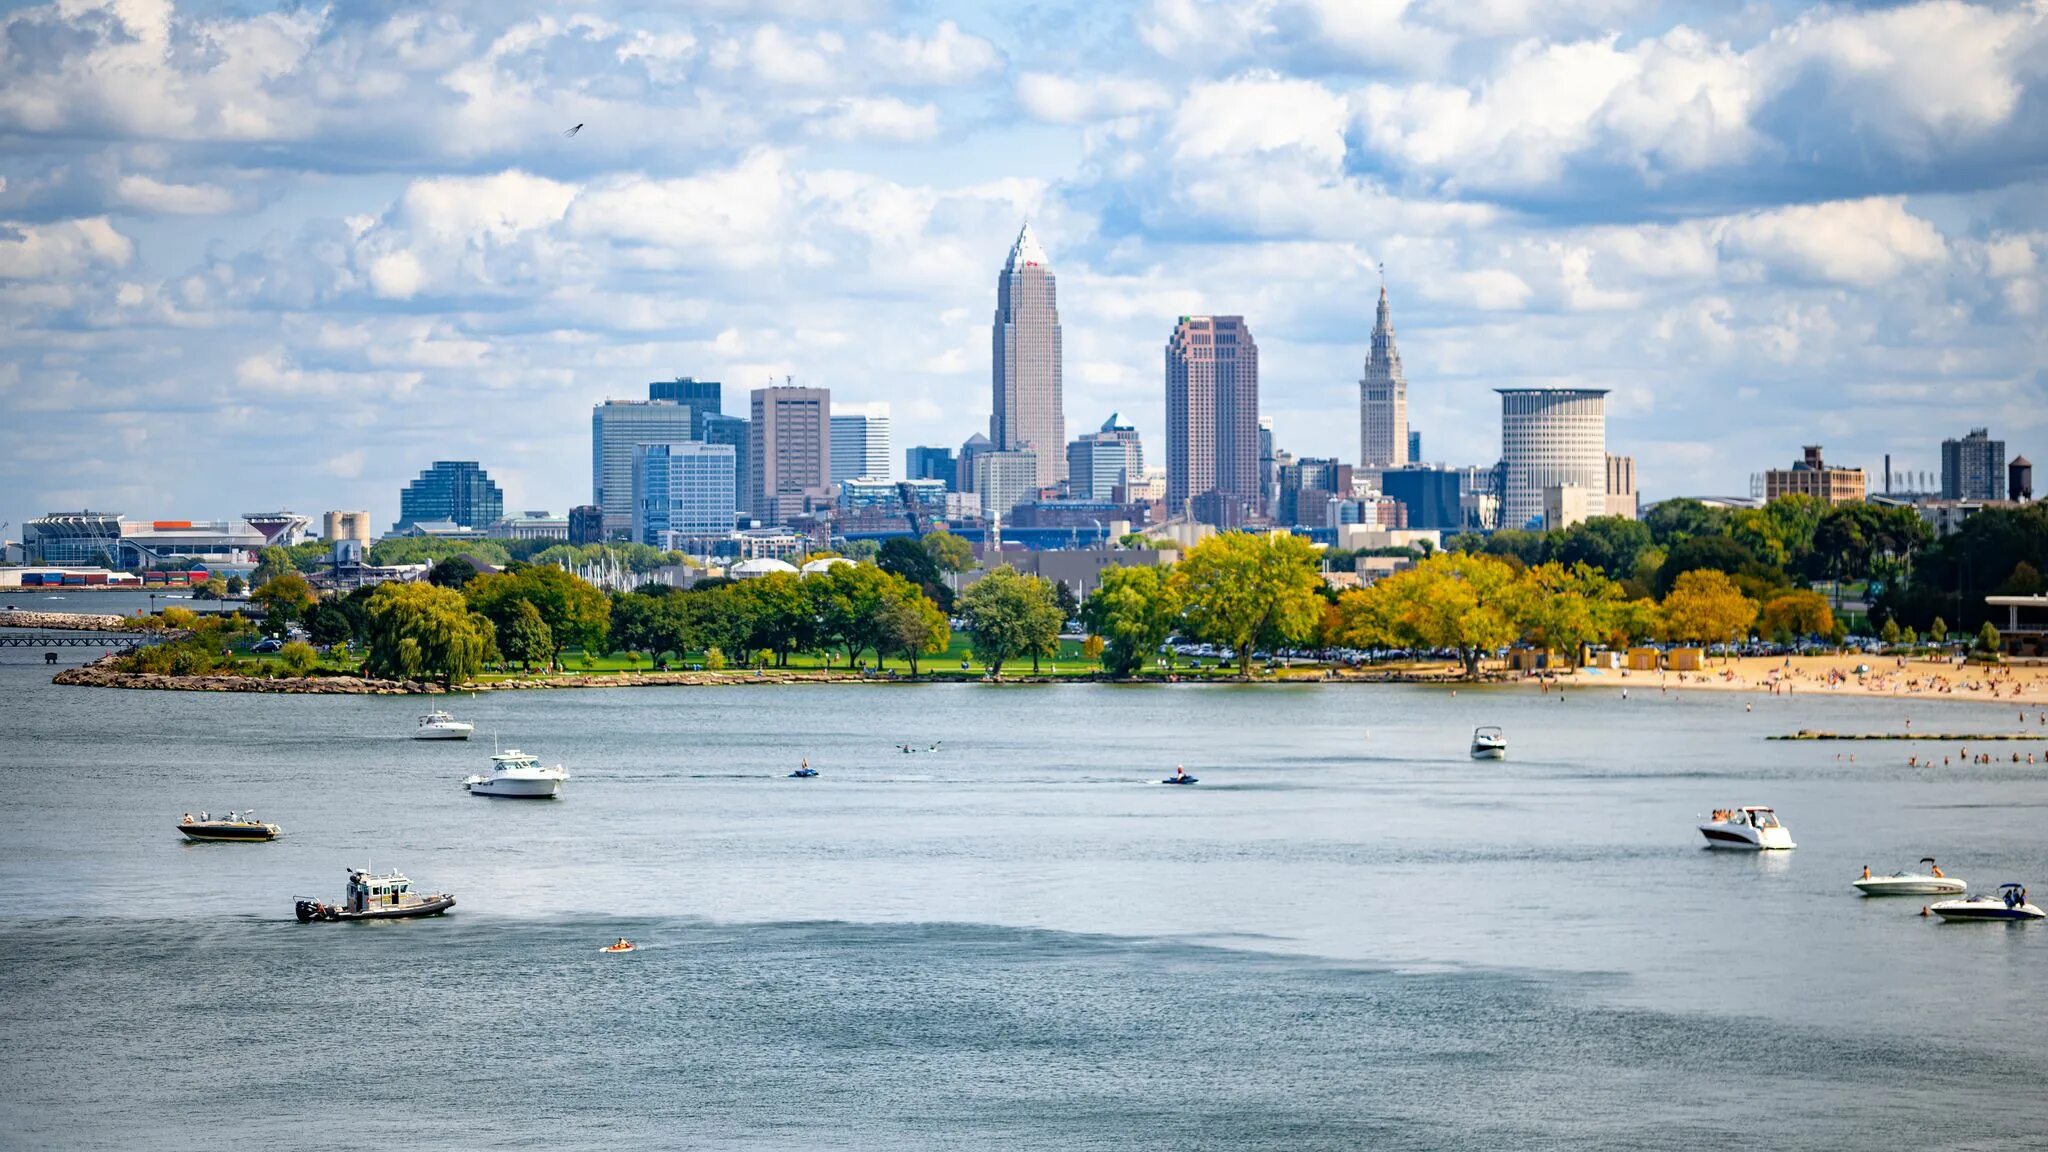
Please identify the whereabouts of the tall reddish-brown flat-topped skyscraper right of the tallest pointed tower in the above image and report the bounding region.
[1165,316,1260,527]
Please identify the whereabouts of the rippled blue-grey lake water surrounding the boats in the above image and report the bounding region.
[0,639,2048,1152]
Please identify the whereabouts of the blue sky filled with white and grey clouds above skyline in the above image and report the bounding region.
[0,0,2048,537]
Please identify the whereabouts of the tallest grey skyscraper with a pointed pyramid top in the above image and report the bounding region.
[989,223,1067,488]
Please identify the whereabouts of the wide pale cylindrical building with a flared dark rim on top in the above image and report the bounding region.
[1495,387,1608,529]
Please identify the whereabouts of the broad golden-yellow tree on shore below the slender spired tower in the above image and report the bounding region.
[1337,551,1522,676]
